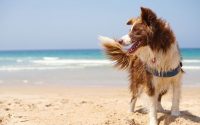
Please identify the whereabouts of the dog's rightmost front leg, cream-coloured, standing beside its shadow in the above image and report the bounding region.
[171,82,181,116]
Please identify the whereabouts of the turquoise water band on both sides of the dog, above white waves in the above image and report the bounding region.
[0,48,200,59]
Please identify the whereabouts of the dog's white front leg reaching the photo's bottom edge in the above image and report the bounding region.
[148,95,157,125]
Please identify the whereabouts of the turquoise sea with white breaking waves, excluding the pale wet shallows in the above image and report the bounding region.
[0,49,200,71]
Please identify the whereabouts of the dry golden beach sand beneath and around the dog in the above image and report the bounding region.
[0,86,200,125]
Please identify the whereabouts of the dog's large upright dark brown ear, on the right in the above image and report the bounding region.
[141,7,157,26]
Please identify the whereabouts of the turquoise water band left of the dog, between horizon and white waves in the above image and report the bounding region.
[0,49,104,59]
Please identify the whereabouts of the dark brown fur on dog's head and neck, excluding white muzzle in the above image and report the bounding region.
[128,7,175,52]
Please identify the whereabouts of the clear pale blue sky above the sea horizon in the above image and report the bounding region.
[0,0,200,50]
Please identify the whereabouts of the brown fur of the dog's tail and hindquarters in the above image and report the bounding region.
[103,42,154,99]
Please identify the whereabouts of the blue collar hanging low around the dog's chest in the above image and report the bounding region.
[146,65,181,77]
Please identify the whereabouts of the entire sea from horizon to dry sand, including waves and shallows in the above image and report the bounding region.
[0,48,200,86]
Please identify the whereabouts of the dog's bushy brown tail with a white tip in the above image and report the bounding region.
[99,36,131,69]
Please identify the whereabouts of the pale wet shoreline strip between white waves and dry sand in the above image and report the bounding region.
[0,66,200,87]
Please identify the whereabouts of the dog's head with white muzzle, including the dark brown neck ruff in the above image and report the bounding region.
[118,7,175,53]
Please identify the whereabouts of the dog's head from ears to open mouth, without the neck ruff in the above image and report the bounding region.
[118,7,157,52]
